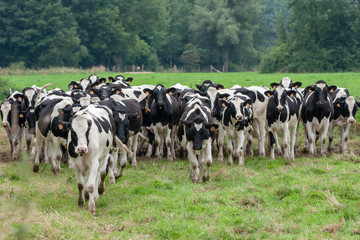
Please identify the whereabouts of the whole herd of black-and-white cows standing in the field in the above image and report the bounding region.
[0,74,360,213]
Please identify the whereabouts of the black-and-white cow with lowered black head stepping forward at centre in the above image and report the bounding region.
[178,103,218,183]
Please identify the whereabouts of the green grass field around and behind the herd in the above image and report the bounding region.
[0,72,360,239]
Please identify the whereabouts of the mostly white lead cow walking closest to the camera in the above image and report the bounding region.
[58,105,114,214]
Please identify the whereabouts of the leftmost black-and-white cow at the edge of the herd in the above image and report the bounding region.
[0,91,24,160]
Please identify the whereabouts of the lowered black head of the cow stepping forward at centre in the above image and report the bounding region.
[181,117,219,150]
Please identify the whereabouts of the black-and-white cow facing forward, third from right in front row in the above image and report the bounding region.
[265,85,299,160]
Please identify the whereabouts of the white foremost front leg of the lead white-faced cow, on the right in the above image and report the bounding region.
[86,159,99,214]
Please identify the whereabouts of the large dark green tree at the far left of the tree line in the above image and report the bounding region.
[0,0,87,67]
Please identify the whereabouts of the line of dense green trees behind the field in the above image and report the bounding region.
[0,0,360,72]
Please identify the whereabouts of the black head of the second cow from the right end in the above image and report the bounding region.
[304,80,337,108]
